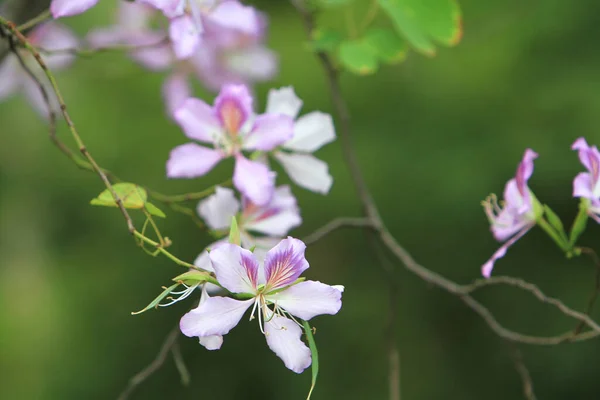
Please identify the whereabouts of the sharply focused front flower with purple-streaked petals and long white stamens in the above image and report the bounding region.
[180,237,343,373]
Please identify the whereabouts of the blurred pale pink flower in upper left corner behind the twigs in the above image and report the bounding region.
[0,22,78,118]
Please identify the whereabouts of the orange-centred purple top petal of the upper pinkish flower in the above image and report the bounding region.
[214,85,252,135]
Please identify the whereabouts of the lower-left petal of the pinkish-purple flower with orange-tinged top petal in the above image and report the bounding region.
[167,143,223,178]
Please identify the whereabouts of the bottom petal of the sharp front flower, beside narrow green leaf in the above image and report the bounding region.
[265,315,312,374]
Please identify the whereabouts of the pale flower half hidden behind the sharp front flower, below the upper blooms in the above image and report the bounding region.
[194,186,302,272]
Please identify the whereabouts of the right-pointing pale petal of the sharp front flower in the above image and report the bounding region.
[267,281,342,321]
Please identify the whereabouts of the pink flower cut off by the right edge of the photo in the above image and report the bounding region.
[571,138,600,223]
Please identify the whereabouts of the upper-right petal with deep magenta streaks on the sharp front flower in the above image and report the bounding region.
[265,237,309,291]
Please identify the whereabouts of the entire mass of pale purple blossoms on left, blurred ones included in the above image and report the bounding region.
[0,0,344,373]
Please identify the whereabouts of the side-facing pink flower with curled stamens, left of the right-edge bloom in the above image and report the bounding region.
[481,149,538,278]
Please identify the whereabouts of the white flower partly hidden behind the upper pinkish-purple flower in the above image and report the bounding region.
[267,87,335,194]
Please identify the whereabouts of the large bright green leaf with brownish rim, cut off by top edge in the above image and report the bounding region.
[378,0,462,56]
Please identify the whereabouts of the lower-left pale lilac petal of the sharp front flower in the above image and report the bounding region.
[179,296,254,337]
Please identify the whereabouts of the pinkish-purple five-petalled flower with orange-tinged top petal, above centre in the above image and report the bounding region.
[167,85,294,206]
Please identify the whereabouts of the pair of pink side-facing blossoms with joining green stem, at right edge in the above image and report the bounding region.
[481,138,600,278]
